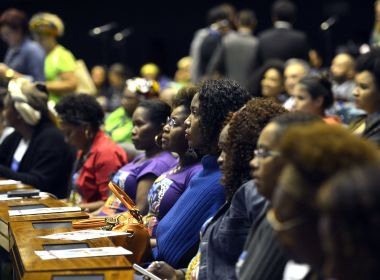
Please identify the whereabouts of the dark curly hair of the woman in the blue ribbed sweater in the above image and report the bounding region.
[199,79,251,153]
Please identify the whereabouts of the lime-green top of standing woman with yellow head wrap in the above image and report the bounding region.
[45,45,76,103]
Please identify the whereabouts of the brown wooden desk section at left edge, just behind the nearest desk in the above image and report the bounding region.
[0,197,88,252]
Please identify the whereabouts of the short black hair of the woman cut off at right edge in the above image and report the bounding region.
[355,47,380,89]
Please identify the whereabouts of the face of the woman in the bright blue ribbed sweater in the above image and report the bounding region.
[185,93,202,149]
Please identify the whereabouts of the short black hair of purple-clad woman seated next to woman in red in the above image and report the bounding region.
[137,99,171,127]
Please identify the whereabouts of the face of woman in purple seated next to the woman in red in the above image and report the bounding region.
[132,107,160,151]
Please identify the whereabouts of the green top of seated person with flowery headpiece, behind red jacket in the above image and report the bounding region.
[104,107,133,143]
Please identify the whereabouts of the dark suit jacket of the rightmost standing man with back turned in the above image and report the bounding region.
[258,28,309,64]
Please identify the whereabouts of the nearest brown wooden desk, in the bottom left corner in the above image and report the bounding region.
[10,220,133,280]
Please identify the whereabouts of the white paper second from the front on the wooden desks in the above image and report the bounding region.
[39,229,129,241]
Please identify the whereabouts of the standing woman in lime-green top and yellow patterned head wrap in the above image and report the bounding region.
[29,13,78,105]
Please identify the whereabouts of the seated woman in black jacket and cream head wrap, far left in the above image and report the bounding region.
[0,79,74,198]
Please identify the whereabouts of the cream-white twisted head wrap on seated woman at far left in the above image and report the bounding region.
[8,78,41,125]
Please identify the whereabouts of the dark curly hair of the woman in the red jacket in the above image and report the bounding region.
[55,94,104,130]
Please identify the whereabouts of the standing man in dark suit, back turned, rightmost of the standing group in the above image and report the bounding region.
[258,0,309,66]
